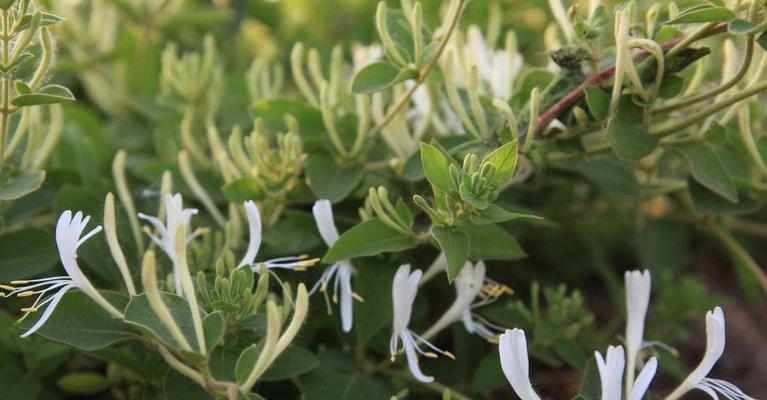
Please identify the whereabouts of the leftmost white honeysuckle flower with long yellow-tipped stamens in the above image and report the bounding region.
[0,210,123,337]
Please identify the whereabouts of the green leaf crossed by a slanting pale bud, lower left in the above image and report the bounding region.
[125,292,206,351]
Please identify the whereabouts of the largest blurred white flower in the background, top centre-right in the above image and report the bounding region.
[464,25,523,100]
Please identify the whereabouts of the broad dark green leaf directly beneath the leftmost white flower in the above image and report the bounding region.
[20,290,136,351]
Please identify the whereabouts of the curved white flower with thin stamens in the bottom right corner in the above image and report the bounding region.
[666,307,754,400]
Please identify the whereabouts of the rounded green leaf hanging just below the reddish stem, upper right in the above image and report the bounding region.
[607,95,658,161]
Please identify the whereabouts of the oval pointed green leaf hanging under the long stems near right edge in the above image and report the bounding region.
[675,142,738,203]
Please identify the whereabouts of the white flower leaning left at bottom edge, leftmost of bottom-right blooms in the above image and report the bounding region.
[498,328,541,400]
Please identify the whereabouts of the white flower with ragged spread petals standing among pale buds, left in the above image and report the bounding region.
[138,194,202,296]
